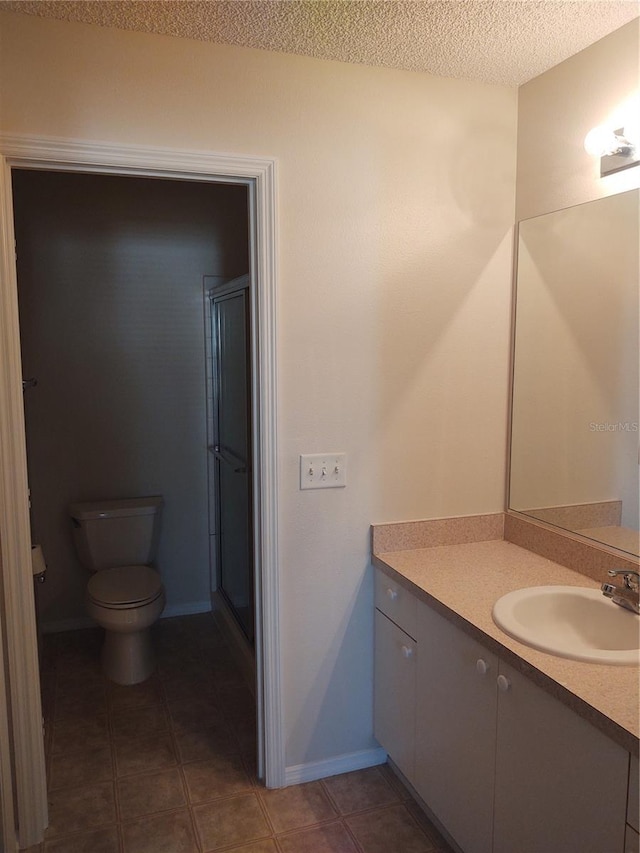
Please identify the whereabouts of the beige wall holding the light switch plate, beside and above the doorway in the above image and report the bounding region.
[0,13,516,765]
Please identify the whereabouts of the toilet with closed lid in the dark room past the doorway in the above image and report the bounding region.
[69,495,166,684]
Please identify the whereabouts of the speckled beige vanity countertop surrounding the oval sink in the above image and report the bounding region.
[373,540,640,755]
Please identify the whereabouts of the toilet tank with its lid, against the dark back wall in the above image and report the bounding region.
[69,495,163,572]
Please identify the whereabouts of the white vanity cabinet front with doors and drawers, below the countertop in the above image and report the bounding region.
[375,572,634,853]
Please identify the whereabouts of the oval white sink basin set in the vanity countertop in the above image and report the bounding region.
[492,586,640,666]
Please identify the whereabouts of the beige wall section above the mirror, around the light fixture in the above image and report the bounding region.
[516,19,640,220]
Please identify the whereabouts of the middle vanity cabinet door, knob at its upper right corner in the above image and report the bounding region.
[414,602,500,853]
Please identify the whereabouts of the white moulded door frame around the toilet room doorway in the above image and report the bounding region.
[0,135,285,847]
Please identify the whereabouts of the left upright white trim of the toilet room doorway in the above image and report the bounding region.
[0,148,47,847]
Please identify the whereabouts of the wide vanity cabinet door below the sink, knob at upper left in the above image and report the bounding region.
[493,663,628,853]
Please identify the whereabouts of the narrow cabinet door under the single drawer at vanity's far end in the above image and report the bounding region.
[374,610,417,782]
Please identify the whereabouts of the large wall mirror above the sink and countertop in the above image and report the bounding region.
[508,190,640,555]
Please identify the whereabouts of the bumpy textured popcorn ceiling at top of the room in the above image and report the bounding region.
[0,0,640,86]
